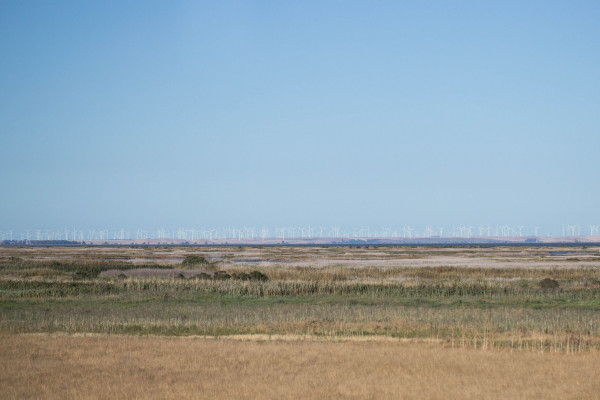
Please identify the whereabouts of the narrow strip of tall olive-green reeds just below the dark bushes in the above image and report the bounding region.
[0,278,600,300]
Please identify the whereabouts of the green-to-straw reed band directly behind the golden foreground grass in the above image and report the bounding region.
[0,296,600,351]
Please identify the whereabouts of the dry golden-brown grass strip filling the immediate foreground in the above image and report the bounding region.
[0,334,600,399]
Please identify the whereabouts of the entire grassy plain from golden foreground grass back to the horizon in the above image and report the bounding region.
[0,246,600,398]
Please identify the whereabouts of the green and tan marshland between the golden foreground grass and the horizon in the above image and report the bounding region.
[0,247,600,353]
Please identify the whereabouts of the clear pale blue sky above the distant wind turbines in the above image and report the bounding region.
[0,0,600,232]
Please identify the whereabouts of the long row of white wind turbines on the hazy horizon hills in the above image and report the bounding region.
[0,224,600,244]
